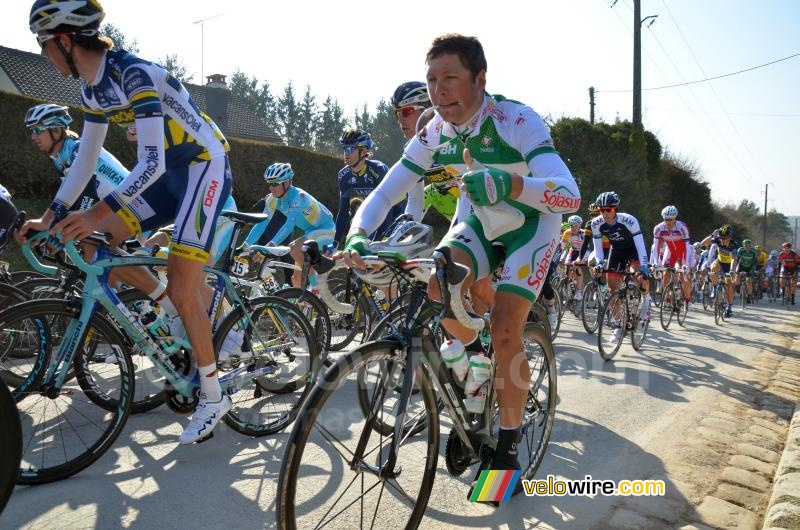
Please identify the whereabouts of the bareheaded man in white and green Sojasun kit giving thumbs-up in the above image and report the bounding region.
[343,35,580,484]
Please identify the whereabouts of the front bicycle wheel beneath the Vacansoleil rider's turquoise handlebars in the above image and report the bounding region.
[3,300,135,485]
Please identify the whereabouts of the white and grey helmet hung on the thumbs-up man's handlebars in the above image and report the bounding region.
[353,221,434,287]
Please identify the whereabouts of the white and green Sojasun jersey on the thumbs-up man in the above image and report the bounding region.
[352,94,580,239]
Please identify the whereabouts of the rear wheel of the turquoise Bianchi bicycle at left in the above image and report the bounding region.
[214,296,320,436]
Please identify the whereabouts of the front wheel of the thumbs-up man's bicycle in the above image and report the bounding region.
[276,341,439,530]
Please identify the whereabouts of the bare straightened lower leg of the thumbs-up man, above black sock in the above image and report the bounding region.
[491,292,531,429]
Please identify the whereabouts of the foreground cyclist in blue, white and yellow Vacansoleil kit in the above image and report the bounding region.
[29,0,232,444]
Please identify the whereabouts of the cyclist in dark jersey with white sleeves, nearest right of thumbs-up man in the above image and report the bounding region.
[592,191,650,342]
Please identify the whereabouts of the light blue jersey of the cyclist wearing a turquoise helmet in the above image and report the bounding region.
[245,186,335,245]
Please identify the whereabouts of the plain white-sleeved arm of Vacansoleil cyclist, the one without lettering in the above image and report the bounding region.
[50,118,108,211]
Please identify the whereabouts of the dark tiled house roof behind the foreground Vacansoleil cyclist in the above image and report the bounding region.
[0,46,283,143]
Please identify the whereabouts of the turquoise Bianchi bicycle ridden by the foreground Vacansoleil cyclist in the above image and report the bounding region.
[7,212,319,484]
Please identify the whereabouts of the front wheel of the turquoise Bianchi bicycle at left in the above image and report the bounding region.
[2,300,135,485]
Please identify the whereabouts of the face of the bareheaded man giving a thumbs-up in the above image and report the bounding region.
[425,53,486,125]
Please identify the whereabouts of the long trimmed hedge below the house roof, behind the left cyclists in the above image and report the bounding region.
[0,92,344,215]
